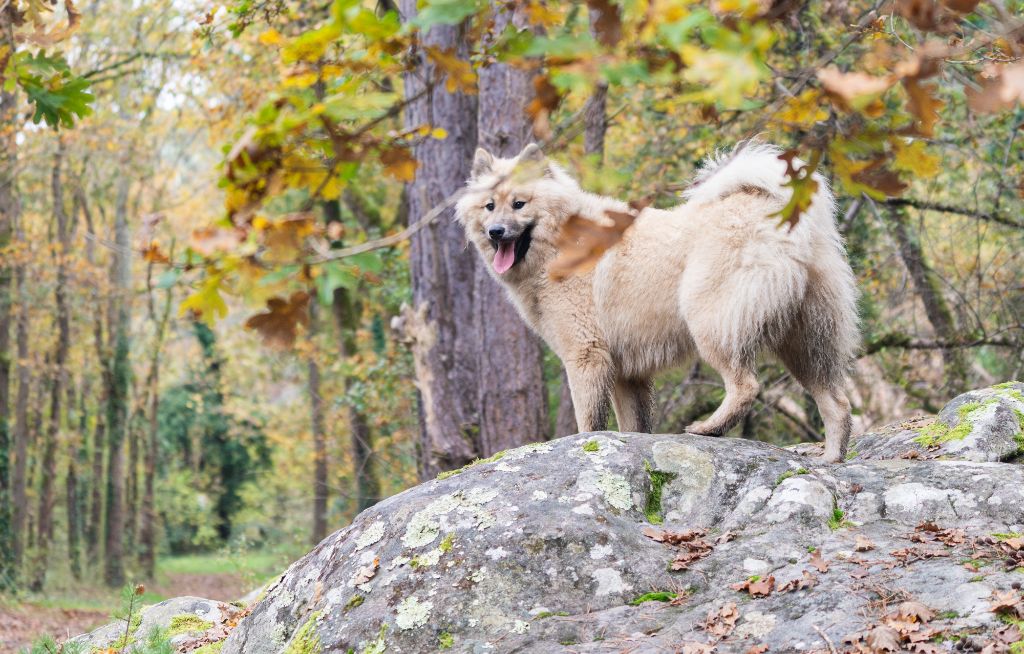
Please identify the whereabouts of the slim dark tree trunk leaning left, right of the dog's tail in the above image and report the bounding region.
[889,207,969,396]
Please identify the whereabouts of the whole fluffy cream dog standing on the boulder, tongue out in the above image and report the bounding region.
[456,143,859,462]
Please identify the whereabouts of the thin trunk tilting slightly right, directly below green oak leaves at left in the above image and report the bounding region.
[30,140,71,592]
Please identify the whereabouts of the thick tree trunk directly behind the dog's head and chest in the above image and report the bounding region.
[473,2,550,456]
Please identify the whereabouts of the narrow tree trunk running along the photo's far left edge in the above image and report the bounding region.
[0,43,18,591]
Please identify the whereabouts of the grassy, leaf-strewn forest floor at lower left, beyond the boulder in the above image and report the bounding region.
[0,553,290,654]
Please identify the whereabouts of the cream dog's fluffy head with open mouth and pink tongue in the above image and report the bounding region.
[456,143,580,282]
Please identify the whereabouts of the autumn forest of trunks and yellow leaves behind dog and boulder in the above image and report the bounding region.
[0,0,1024,650]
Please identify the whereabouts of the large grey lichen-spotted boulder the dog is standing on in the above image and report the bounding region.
[222,384,1024,654]
